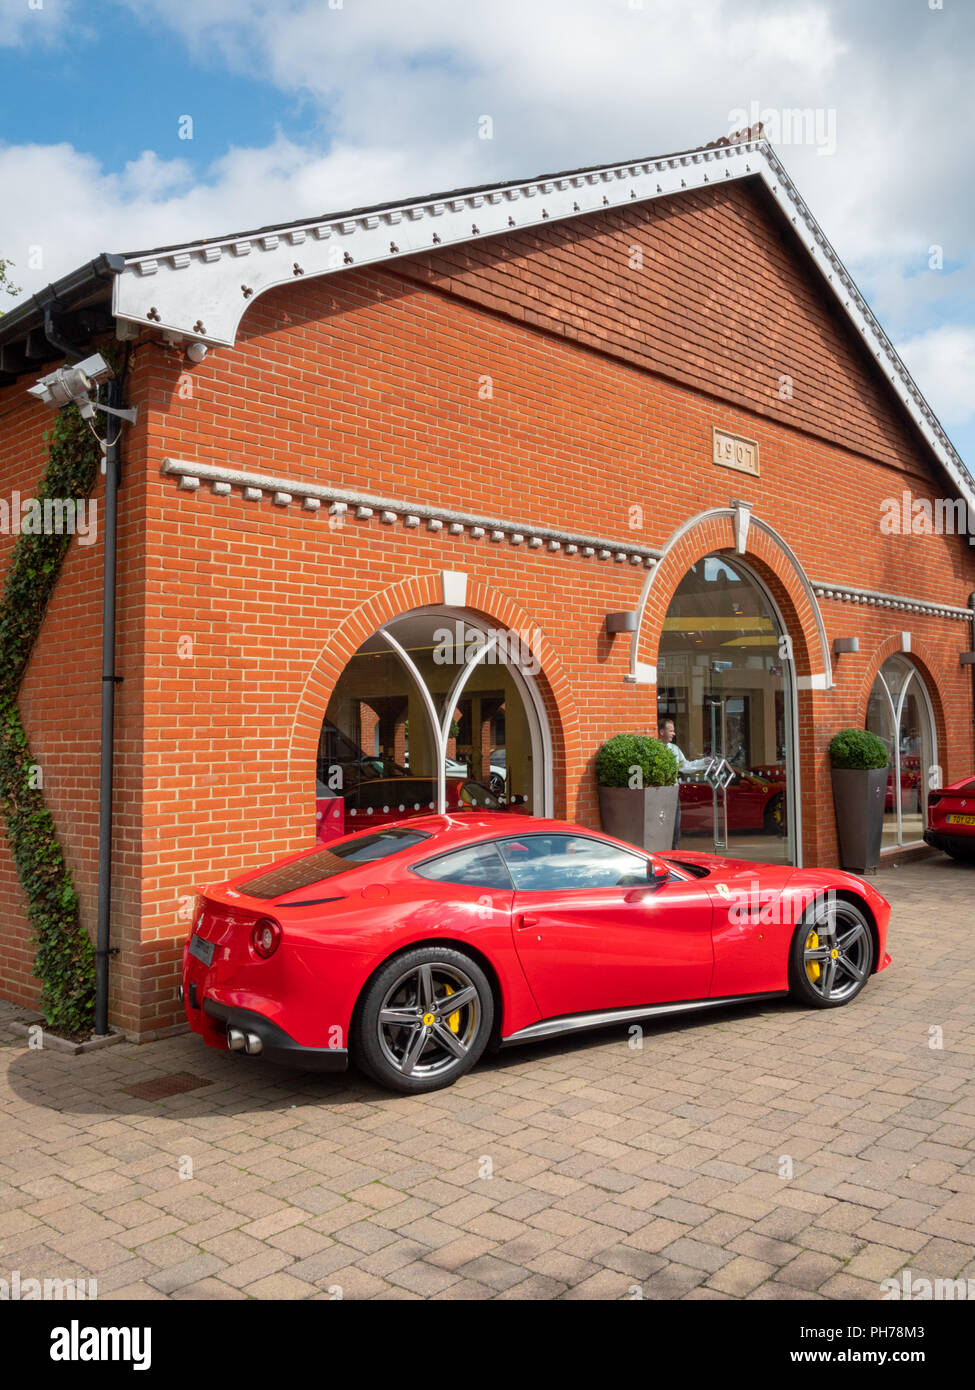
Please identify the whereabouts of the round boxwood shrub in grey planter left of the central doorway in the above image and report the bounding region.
[595,734,677,852]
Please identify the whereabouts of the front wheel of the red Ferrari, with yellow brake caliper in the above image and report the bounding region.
[789,898,873,1009]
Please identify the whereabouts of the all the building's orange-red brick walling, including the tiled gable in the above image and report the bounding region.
[0,176,975,1033]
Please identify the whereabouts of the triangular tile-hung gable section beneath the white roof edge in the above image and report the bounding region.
[395,181,934,467]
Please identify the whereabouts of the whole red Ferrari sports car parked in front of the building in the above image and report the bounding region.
[181,810,890,1093]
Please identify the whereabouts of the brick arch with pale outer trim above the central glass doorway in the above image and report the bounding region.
[634,507,832,684]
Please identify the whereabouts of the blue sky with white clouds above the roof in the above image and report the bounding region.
[0,0,975,467]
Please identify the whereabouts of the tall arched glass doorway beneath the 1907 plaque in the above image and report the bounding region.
[656,553,798,863]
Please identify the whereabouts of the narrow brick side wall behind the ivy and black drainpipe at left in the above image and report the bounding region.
[0,358,146,1027]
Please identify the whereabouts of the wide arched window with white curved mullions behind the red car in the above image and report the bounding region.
[317,607,552,838]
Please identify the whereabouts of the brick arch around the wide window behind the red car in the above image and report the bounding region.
[289,571,581,816]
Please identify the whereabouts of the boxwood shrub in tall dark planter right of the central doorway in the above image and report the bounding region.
[829,728,890,873]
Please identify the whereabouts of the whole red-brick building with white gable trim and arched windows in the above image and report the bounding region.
[0,131,975,1036]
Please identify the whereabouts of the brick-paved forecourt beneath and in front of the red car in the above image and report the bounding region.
[0,858,975,1300]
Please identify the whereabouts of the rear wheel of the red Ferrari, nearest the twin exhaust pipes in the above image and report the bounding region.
[353,947,494,1094]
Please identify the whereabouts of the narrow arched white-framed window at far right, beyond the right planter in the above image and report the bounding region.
[867,655,937,849]
